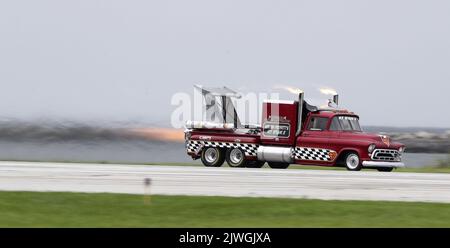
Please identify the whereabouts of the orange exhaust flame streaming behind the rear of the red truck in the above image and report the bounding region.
[128,128,184,142]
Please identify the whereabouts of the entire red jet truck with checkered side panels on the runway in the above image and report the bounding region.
[185,86,405,172]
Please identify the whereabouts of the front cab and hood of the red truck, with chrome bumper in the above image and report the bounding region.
[295,110,405,171]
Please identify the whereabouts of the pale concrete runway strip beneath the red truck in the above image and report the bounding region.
[0,162,450,203]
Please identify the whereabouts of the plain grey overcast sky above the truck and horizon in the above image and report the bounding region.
[0,0,450,127]
